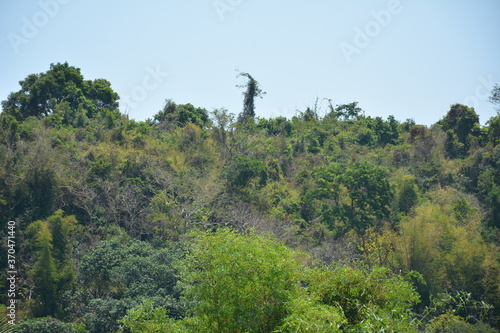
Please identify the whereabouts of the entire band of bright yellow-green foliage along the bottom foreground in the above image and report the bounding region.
[123,229,419,333]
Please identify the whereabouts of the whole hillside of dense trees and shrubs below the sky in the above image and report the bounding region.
[0,63,500,333]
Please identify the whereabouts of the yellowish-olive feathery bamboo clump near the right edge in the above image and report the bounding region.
[393,189,498,308]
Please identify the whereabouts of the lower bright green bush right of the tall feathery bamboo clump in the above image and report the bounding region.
[307,266,419,332]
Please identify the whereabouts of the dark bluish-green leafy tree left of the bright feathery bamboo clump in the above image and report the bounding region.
[79,232,184,333]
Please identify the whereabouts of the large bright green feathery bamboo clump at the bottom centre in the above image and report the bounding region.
[174,229,298,333]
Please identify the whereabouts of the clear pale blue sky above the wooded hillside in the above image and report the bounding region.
[0,0,500,125]
